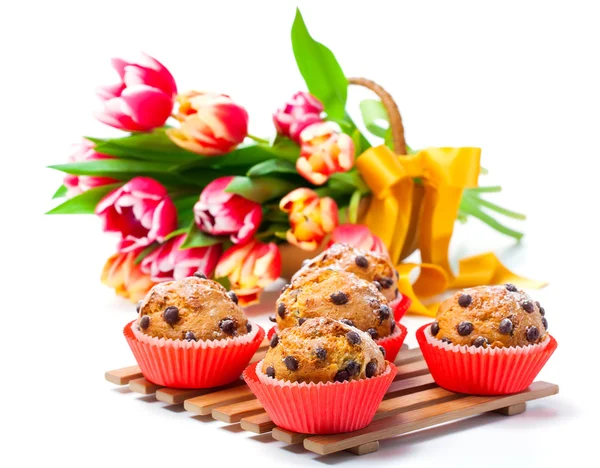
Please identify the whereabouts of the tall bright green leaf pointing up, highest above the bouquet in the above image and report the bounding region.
[292,9,348,120]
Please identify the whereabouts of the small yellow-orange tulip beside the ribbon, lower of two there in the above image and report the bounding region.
[279,188,338,250]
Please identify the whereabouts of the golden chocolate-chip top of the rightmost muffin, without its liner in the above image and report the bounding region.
[431,284,548,348]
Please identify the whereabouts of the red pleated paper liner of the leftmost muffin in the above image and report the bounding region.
[123,321,265,388]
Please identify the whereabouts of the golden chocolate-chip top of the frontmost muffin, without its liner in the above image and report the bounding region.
[262,317,386,383]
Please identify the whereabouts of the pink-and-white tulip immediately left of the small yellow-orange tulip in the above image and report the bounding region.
[194,177,262,244]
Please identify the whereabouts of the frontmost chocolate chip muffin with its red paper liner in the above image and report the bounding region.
[244,317,397,434]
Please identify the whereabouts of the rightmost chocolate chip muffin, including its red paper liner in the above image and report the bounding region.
[417,284,557,395]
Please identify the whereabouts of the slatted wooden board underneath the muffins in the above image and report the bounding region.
[105,340,558,455]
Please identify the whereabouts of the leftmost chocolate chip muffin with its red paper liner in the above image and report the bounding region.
[123,273,264,388]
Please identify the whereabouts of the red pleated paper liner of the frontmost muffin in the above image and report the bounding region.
[244,361,397,434]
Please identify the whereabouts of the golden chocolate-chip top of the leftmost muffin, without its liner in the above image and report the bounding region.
[137,274,252,341]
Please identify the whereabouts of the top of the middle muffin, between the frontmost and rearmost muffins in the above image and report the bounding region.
[275,268,396,339]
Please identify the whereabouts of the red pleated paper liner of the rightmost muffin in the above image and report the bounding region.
[417,324,558,395]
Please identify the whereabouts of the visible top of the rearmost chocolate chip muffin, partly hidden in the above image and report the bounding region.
[292,244,399,302]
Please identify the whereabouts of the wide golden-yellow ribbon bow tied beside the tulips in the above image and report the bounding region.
[356,146,545,316]
